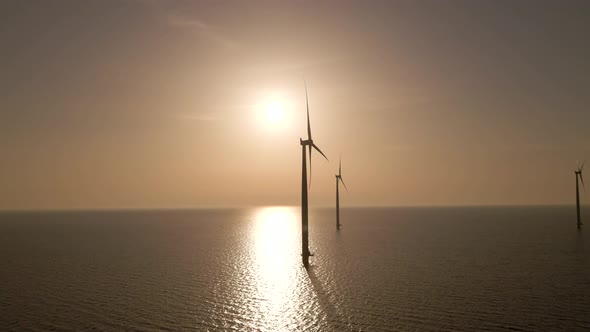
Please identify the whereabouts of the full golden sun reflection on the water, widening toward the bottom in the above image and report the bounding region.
[207,207,342,331]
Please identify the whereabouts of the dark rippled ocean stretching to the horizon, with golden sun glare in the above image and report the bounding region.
[0,207,590,331]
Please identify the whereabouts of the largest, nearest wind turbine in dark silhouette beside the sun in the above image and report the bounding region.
[299,80,328,268]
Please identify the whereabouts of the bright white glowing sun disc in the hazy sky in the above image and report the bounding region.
[257,94,294,130]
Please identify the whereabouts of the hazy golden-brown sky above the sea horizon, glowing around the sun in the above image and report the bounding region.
[0,0,590,209]
